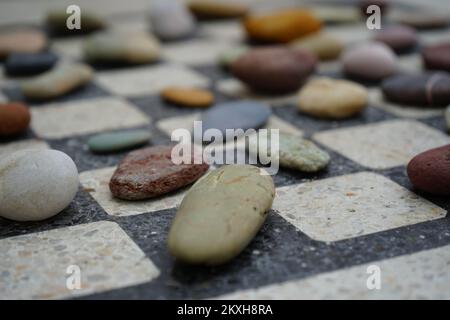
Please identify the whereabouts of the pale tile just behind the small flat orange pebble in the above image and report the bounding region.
[97,64,210,96]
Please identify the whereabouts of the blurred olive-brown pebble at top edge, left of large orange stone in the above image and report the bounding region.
[188,0,248,19]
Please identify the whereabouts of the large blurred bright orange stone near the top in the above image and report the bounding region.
[243,9,322,43]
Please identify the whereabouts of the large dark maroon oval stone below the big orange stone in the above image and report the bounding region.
[231,47,317,93]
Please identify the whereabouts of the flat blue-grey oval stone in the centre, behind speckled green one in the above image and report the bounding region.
[194,100,272,140]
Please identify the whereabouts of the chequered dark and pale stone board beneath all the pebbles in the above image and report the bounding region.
[0,0,450,299]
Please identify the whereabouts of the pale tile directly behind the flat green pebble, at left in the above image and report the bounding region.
[31,97,150,139]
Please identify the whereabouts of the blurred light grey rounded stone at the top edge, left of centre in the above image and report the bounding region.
[150,0,195,40]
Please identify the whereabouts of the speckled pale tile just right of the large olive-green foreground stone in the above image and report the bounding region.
[272,172,446,242]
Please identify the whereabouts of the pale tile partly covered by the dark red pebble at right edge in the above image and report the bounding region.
[313,120,450,169]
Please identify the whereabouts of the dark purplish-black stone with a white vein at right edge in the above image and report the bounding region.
[382,72,450,106]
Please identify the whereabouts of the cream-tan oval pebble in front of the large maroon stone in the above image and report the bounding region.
[298,77,368,119]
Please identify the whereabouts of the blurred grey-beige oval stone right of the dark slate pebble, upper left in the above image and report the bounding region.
[84,32,160,64]
